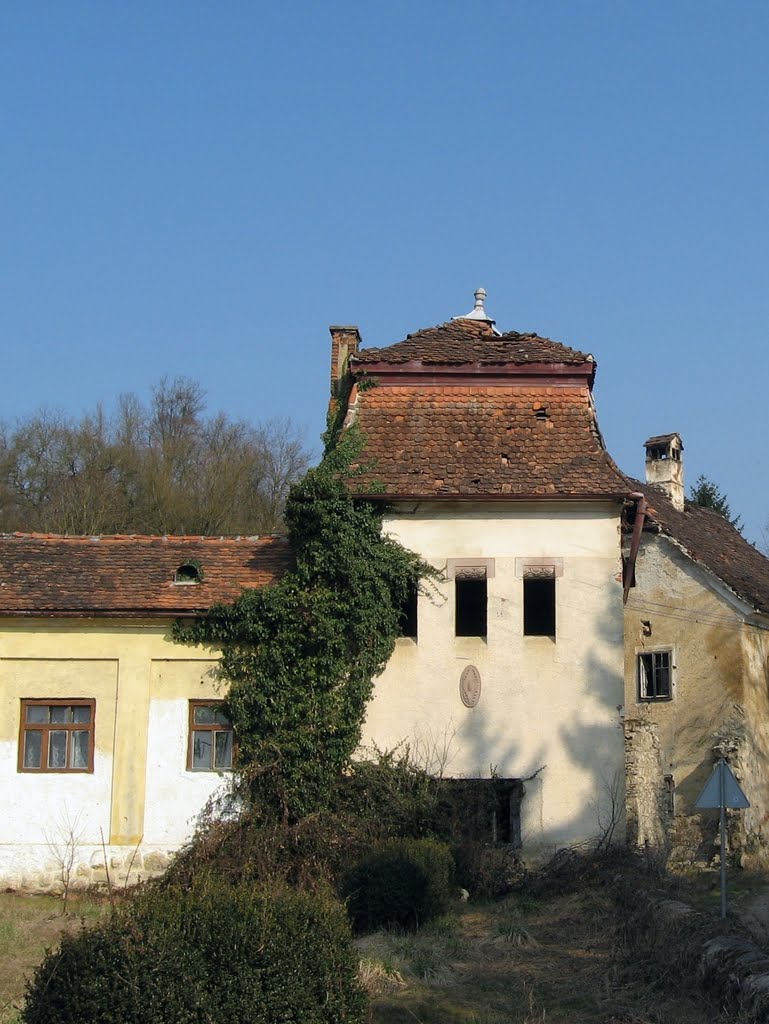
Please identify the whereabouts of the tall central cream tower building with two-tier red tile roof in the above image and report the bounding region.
[331,291,631,853]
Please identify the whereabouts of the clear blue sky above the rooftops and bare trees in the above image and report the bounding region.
[0,0,769,540]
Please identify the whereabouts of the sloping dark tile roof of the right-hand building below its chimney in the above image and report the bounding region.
[631,480,769,613]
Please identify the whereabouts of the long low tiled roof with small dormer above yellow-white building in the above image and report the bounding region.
[0,534,292,617]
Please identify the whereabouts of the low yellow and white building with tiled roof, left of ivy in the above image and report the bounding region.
[0,535,291,888]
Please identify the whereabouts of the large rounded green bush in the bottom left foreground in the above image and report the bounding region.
[22,877,367,1024]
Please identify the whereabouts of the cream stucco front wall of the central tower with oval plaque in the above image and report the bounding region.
[364,502,624,851]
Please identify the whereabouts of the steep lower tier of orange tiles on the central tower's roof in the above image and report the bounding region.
[354,381,632,498]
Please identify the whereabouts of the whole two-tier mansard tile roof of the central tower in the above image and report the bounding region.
[346,318,630,499]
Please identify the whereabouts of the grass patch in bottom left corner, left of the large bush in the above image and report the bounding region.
[0,893,104,1024]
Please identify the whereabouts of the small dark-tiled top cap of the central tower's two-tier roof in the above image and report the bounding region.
[350,321,592,369]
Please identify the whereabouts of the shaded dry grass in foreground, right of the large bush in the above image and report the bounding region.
[361,886,732,1024]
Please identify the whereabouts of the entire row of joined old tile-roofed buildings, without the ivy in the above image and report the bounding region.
[7,290,769,887]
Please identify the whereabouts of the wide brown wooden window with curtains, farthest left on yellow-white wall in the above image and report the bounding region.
[18,699,95,772]
